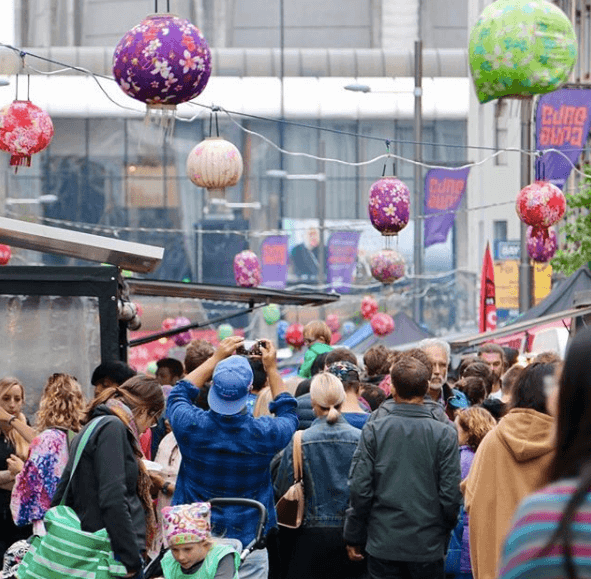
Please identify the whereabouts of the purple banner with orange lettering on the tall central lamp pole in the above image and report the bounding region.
[424,167,470,247]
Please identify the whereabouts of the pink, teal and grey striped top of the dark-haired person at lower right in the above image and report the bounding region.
[499,479,591,579]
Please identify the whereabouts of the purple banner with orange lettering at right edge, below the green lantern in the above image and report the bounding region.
[536,88,591,189]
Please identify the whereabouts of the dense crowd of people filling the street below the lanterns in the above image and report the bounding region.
[0,320,591,579]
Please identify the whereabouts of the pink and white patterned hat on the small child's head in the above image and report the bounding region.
[162,503,211,547]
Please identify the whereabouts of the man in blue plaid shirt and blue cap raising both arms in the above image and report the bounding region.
[166,336,298,579]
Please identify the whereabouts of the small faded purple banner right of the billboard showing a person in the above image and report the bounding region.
[326,231,360,294]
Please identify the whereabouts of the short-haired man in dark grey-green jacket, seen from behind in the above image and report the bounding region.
[344,356,462,579]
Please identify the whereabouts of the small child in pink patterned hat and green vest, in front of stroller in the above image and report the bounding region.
[161,503,240,579]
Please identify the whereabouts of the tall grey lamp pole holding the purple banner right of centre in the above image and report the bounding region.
[413,40,423,324]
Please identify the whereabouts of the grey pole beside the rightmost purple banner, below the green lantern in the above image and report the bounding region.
[519,97,532,313]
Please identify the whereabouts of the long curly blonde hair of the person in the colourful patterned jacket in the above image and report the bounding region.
[35,373,86,432]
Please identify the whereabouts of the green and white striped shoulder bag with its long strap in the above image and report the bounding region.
[17,418,127,579]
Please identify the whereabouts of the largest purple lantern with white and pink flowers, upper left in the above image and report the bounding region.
[113,14,211,113]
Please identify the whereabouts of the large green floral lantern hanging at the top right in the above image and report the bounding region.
[469,0,577,103]
